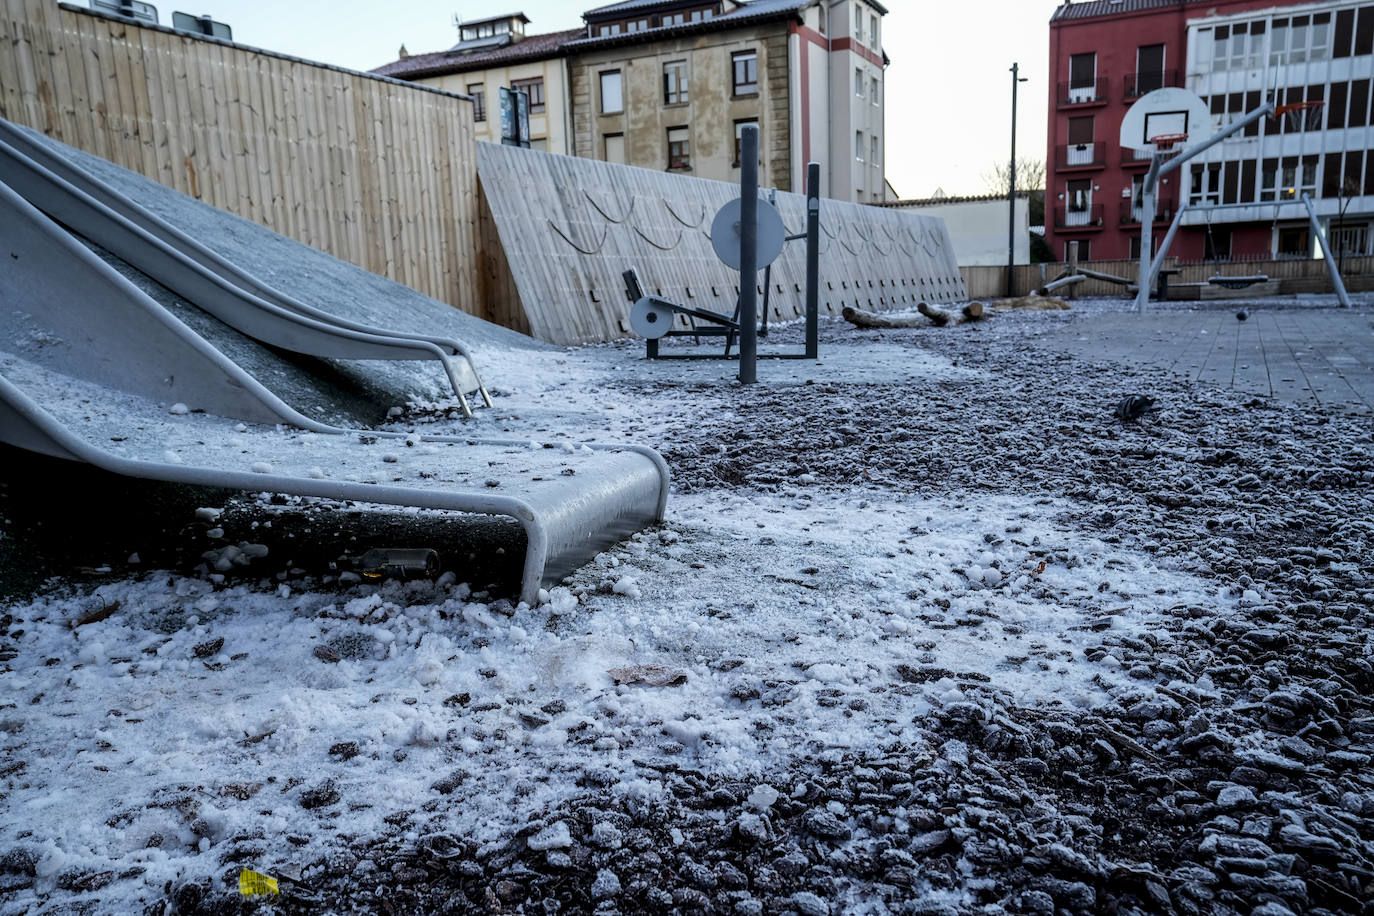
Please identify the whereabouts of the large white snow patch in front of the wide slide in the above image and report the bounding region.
[0,492,1232,912]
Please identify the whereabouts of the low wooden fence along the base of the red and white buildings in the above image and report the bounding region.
[959,255,1374,299]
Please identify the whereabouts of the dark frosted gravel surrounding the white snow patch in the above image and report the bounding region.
[0,302,1374,916]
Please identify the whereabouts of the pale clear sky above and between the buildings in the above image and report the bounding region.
[188,0,1059,198]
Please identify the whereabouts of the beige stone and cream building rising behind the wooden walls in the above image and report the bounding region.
[376,0,888,203]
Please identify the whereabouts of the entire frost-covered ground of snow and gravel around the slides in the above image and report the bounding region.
[0,297,1374,916]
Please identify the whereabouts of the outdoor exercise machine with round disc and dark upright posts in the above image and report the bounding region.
[622,125,820,385]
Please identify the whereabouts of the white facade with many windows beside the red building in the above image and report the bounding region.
[1182,0,1374,260]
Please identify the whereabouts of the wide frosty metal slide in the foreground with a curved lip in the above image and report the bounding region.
[0,184,668,602]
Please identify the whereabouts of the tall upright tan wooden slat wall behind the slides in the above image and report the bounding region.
[0,0,484,314]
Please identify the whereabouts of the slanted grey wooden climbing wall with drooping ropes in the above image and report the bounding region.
[478,143,966,345]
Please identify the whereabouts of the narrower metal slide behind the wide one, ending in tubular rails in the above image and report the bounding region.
[0,118,492,416]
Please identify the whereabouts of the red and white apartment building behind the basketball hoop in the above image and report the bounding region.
[1046,0,1374,260]
